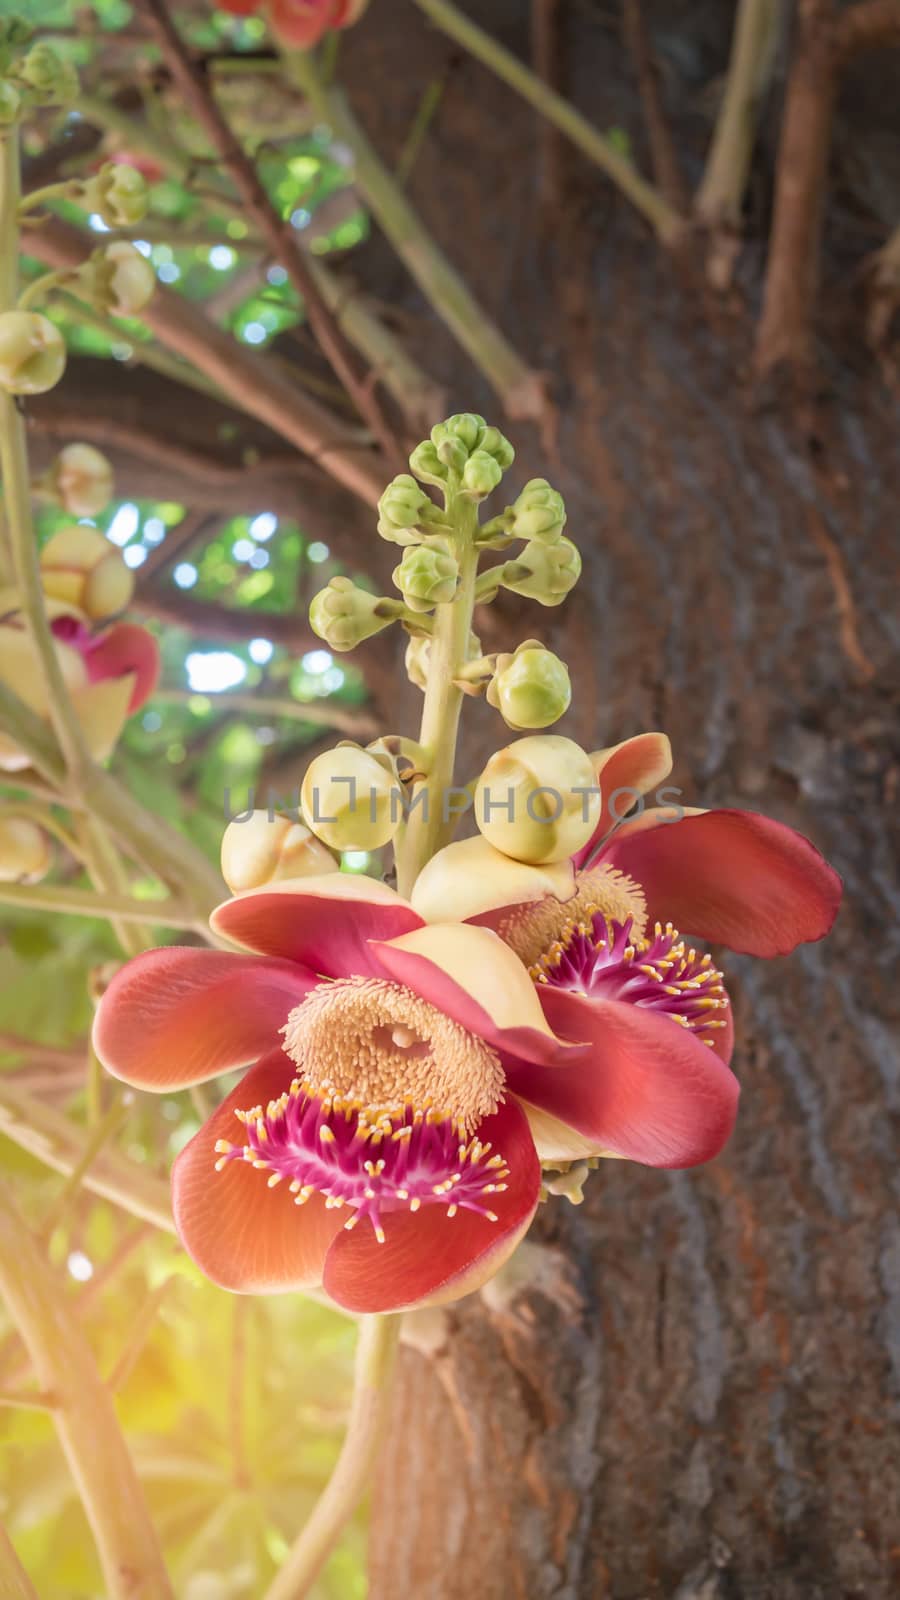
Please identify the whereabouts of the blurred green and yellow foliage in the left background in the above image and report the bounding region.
[0,0,381,1600]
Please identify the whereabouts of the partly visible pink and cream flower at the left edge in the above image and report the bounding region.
[0,590,159,773]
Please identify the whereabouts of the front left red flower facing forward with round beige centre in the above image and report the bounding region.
[94,874,737,1312]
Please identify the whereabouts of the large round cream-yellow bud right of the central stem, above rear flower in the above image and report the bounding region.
[476,733,601,866]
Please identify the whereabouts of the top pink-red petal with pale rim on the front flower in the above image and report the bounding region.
[210,872,423,978]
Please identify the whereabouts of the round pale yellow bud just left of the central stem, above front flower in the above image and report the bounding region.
[299,744,400,850]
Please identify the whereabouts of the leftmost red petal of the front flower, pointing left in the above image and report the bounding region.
[94,947,315,1090]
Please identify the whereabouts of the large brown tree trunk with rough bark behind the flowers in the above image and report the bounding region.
[329,0,900,1600]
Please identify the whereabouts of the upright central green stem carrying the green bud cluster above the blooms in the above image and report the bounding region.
[396,496,479,896]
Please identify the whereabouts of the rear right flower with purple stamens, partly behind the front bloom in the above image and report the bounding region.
[412,733,841,1158]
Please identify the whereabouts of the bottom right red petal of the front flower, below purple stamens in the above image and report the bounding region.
[323,1101,541,1312]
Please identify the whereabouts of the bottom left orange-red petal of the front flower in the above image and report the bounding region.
[171,1050,341,1294]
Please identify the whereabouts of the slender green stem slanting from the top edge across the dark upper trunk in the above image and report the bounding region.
[415,0,684,245]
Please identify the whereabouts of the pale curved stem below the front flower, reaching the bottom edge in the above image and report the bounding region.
[264,1315,402,1600]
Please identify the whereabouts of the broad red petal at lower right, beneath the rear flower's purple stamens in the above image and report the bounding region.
[508,984,740,1166]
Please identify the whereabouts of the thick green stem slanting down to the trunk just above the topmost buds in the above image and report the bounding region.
[287,51,544,418]
